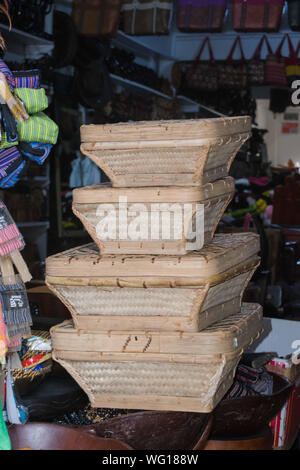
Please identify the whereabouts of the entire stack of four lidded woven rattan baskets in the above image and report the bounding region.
[46,117,262,412]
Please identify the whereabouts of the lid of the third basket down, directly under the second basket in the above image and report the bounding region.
[46,232,260,288]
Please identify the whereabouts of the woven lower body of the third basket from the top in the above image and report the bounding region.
[47,257,259,331]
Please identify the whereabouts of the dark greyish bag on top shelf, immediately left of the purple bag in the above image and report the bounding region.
[121,0,173,35]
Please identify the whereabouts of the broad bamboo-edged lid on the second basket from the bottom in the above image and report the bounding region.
[46,232,260,283]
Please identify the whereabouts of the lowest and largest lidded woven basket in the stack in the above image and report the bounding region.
[51,304,263,413]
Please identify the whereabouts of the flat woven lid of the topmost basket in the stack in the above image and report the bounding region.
[80,116,252,145]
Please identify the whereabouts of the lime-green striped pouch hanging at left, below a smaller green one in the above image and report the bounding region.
[18,112,58,144]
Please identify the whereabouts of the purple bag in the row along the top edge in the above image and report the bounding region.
[177,0,228,32]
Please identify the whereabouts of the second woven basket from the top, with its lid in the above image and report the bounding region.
[73,177,234,255]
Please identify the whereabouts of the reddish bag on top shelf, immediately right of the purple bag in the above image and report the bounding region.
[233,0,284,32]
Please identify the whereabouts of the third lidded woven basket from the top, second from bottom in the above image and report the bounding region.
[46,233,259,331]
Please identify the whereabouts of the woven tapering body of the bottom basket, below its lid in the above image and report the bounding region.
[52,304,261,412]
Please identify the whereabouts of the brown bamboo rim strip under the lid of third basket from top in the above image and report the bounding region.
[46,256,260,289]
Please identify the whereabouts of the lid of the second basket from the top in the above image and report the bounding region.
[73,176,235,204]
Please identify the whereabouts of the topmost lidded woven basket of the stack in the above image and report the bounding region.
[81,116,251,187]
